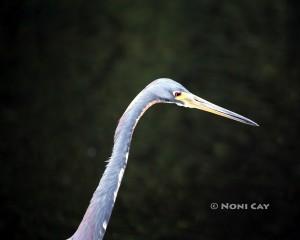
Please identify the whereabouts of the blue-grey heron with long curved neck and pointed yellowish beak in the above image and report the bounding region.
[69,78,258,240]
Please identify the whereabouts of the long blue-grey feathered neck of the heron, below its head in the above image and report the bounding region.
[70,90,158,240]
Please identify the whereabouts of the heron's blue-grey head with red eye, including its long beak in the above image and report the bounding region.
[148,78,258,126]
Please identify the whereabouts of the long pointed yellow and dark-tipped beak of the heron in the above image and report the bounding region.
[176,92,259,126]
